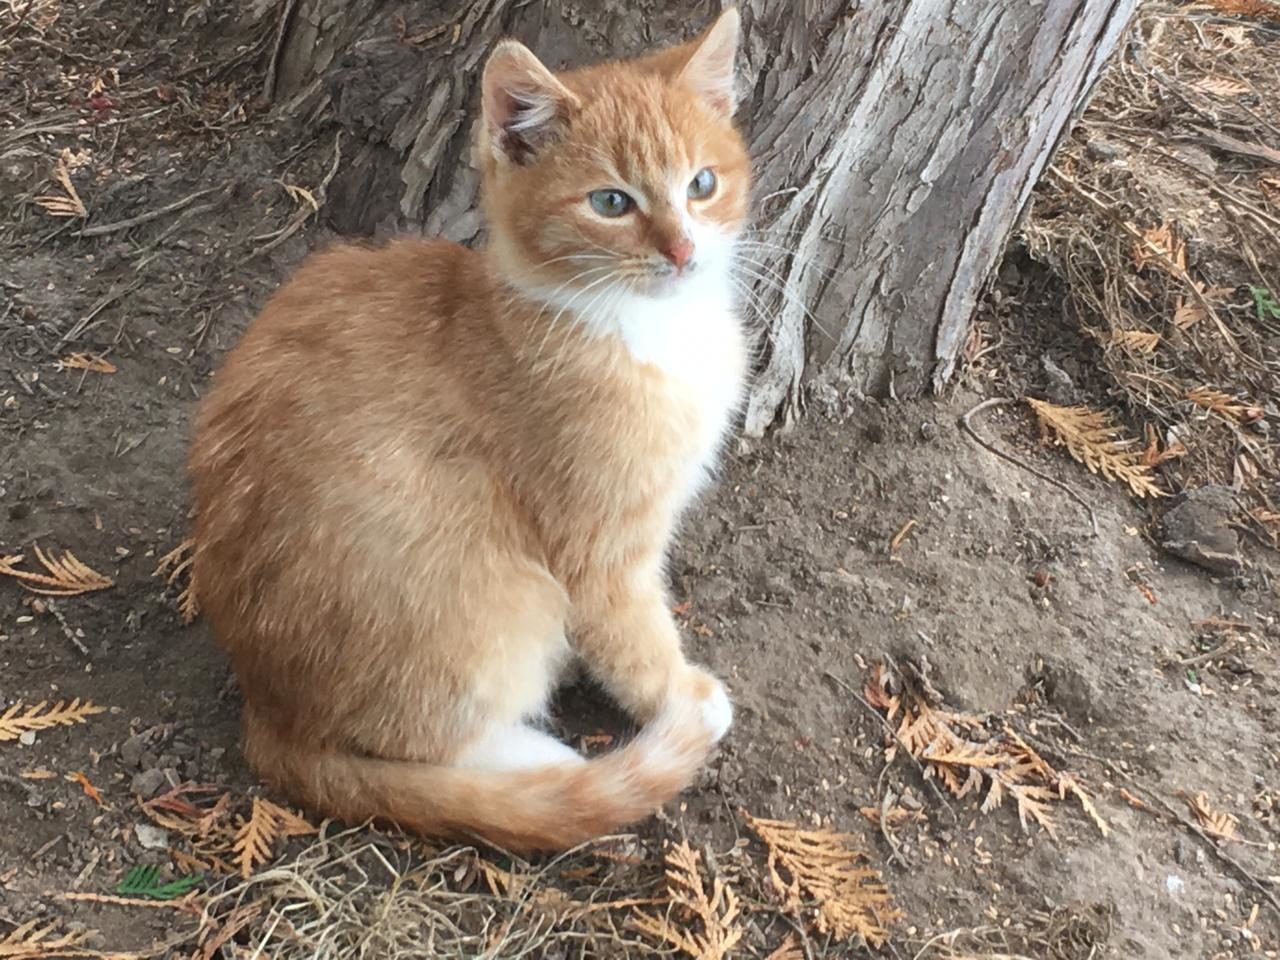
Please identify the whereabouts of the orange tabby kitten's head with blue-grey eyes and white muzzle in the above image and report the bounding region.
[477,9,750,312]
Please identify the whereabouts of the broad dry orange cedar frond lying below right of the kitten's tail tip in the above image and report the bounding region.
[742,810,901,947]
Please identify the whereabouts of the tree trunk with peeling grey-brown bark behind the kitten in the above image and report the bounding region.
[264,0,1135,434]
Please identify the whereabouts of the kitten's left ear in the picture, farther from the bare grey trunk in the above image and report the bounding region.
[481,40,577,164]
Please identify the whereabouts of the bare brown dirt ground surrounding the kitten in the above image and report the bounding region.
[0,0,1280,960]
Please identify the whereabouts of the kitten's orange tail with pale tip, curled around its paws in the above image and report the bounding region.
[244,686,732,852]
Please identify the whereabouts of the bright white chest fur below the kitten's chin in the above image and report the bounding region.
[616,279,746,500]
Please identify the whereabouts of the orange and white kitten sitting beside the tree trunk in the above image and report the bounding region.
[189,9,750,851]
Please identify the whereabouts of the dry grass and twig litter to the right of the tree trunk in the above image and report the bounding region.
[1024,0,1280,543]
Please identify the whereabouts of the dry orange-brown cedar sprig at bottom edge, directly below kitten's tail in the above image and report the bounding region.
[631,840,742,960]
